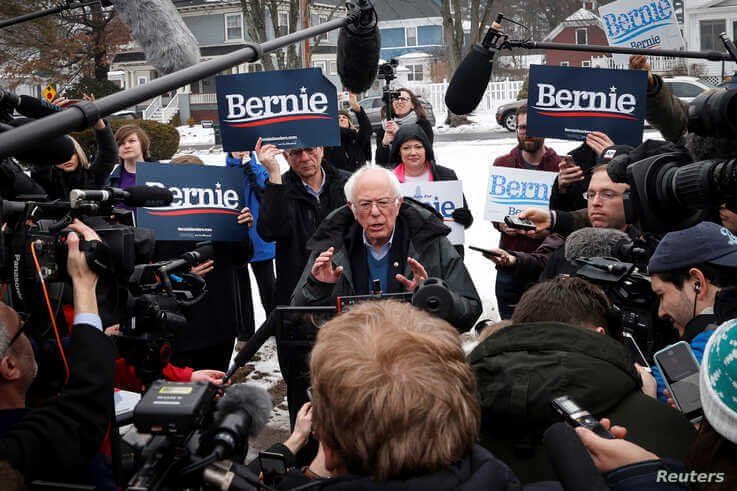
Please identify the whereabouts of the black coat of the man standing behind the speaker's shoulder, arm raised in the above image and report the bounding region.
[257,161,347,305]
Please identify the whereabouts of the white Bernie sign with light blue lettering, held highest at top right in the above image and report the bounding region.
[599,0,686,65]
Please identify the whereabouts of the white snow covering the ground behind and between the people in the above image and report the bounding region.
[182,127,660,454]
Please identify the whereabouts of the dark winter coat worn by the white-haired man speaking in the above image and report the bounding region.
[292,198,481,332]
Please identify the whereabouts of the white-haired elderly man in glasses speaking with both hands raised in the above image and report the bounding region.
[292,165,481,332]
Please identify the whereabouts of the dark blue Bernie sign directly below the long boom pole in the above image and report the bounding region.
[215,68,340,152]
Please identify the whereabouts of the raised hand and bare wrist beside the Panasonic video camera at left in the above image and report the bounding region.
[67,218,100,314]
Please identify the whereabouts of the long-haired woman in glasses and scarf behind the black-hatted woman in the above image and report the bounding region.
[376,89,435,167]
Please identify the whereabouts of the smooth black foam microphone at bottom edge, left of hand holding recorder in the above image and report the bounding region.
[543,423,609,491]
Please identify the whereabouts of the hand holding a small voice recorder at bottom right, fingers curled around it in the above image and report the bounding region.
[575,419,659,472]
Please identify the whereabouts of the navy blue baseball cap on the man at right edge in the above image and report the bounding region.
[647,222,737,274]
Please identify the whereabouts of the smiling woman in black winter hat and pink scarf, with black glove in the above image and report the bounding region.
[389,124,473,258]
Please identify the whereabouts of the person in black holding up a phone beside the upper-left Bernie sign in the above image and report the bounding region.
[325,93,371,172]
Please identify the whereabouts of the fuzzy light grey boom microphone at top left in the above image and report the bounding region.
[112,0,200,74]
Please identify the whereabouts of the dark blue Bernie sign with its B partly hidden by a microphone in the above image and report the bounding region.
[136,163,248,242]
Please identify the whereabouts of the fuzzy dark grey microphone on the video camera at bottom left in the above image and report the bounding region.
[210,384,272,460]
